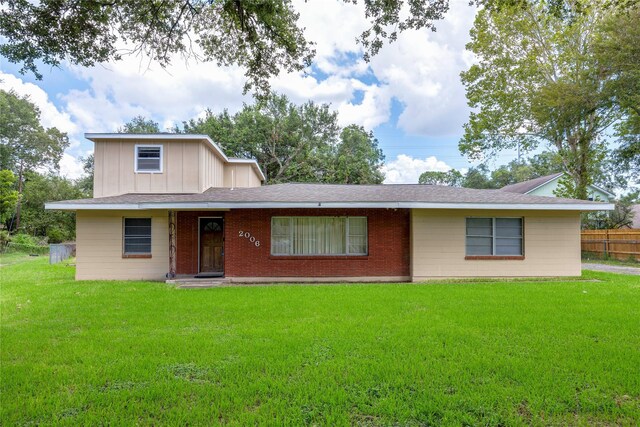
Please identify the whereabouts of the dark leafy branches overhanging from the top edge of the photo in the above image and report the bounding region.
[0,0,448,94]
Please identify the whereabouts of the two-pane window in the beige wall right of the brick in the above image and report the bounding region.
[467,218,523,256]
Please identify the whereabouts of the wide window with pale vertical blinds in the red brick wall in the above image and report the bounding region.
[271,216,367,255]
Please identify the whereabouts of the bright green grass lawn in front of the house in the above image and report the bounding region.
[0,258,640,426]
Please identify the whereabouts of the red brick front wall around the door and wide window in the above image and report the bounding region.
[176,209,410,277]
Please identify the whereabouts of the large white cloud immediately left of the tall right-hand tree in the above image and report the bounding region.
[364,0,476,136]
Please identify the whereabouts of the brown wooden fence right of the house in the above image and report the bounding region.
[582,228,640,261]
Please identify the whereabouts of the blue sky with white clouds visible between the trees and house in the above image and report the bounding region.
[0,0,515,183]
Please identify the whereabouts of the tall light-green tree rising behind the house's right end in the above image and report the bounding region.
[460,0,622,199]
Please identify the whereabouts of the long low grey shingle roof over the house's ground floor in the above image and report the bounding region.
[48,184,604,209]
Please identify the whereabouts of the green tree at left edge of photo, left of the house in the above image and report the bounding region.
[0,90,69,229]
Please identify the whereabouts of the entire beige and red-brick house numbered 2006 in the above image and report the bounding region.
[46,134,612,282]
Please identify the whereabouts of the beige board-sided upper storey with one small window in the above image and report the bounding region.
[85,133,265,197]
